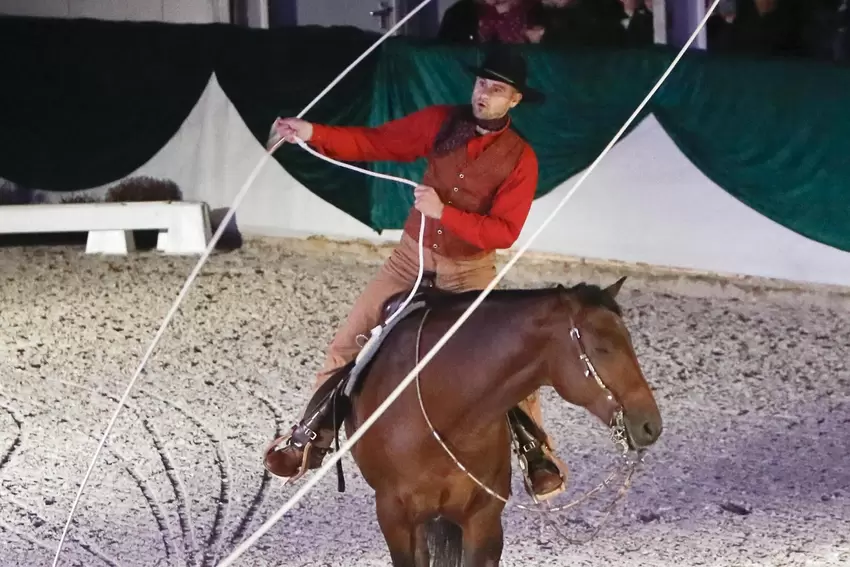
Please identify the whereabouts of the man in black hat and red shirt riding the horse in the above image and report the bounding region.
[265,46,566,500]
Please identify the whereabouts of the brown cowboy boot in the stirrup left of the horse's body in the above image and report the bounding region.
[263,391,337,481]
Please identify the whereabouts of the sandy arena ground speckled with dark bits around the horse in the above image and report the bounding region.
[0,236,850,567]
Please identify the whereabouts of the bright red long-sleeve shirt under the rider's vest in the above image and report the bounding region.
[310,105,537,250]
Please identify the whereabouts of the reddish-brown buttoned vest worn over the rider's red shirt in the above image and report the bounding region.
[404,122,526,258]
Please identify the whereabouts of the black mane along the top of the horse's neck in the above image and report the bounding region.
[420,282,623,316]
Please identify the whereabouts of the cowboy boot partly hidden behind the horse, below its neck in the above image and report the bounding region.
[508,408,566,502]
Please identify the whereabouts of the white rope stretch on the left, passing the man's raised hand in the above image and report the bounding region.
[53,0,438,567]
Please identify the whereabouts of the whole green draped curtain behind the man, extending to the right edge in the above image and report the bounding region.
[358,41,850,251]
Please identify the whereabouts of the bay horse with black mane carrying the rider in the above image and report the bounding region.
[282,278,662,567]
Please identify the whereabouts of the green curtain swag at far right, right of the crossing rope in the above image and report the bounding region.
[652,51,850,255]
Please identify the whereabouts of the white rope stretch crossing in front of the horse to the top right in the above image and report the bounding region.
[217,0,720,567]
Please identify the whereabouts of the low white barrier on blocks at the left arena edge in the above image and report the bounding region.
[0,201,212,254]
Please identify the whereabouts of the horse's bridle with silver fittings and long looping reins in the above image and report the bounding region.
[416,308,643,544]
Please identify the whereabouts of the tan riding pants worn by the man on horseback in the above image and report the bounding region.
[314,233,551,446]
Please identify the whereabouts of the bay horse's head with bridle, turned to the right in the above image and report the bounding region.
[549,277,662,449]
